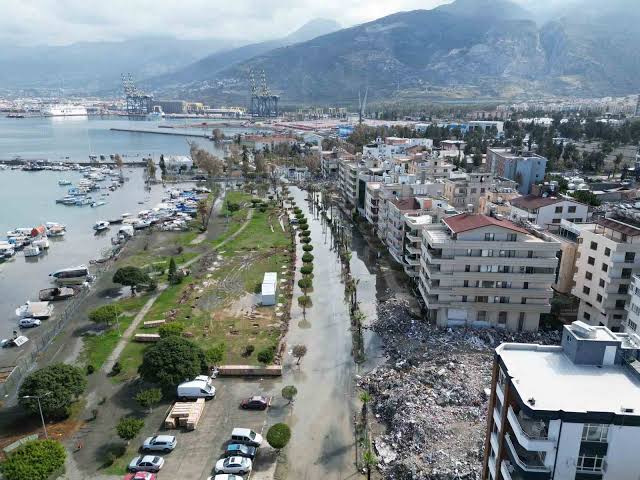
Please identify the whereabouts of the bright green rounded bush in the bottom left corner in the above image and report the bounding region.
[0,440,67,480]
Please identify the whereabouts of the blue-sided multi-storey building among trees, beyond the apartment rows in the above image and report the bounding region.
[487,148,547,195]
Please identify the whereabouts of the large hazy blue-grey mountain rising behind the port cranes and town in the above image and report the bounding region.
[153,0,640,103]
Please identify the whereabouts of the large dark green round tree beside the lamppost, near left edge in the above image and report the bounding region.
[18,363,87,418]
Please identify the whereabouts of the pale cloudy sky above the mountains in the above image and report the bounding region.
[0,0,560,45]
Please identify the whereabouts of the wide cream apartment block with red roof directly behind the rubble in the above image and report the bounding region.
[419,213,559,331]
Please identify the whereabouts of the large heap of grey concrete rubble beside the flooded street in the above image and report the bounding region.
[359,299,560,480]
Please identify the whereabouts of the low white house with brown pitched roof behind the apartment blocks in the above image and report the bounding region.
[509,195,590,228]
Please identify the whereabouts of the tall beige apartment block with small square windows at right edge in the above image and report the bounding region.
[572,218,640,331]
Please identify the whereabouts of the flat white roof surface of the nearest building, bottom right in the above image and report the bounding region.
[496,343,640,415]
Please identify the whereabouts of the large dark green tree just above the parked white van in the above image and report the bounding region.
[138,336,208,388]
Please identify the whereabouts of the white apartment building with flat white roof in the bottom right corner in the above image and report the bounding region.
[482,321,640,480]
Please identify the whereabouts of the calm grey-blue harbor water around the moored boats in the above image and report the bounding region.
[0,117,255,342]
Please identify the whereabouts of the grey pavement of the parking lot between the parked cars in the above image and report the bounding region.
[150,378,289,480]
